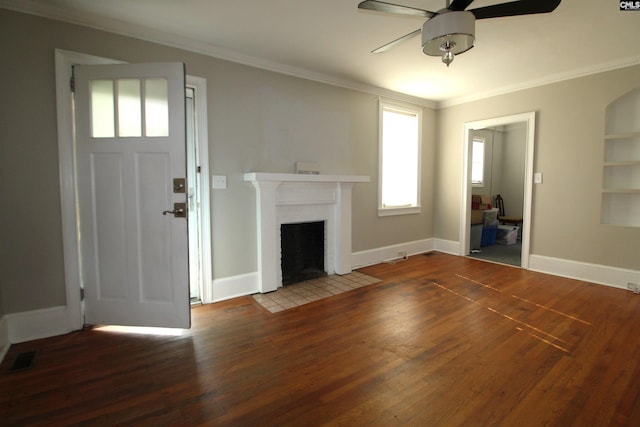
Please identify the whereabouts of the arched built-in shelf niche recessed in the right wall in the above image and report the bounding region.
[602,89,640,227]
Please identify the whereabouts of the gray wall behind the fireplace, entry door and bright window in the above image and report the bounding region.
[0,9,436,314]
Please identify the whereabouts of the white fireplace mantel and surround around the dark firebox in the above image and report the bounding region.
[244,172,370,293]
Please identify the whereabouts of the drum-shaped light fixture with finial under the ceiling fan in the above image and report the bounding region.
[422,11,476,66]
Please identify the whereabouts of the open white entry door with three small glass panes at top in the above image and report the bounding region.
[74,63,190,328]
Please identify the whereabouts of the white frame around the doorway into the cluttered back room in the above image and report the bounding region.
[460,111,536,269]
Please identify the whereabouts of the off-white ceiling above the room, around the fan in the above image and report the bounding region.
[0,0,640,106]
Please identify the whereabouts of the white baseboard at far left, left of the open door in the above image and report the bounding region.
[5,306,71,344]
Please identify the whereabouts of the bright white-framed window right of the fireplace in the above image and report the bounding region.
[378,101,422,216]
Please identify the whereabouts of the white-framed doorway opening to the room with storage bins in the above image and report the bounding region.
[460,112,535,269]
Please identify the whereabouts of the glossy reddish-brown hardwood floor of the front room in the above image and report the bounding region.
[0,254,640,427]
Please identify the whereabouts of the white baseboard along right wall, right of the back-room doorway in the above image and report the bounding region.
[529,255,640,289]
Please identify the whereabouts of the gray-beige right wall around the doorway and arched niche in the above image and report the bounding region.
[434,66,640,270]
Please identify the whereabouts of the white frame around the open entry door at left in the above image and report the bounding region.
[55,49,213,330]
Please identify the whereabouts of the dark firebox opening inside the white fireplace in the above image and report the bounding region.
[280,221,327,285]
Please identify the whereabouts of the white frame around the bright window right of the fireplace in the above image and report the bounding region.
[378,99,422,216]
